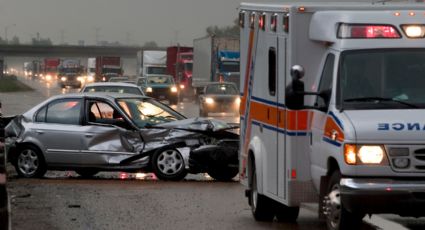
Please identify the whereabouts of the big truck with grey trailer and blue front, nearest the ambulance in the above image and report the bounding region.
[192,36,240,94]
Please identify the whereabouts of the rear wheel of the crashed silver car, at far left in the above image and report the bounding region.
[15,145,47,178]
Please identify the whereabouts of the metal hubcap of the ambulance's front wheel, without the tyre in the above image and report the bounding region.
[323,184,341,229]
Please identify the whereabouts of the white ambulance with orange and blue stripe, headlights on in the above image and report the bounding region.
[239,1,425,229]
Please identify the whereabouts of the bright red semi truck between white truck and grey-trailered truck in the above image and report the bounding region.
[167,46,193,97]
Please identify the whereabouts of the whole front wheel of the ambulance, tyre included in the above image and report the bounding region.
[323,171,364,230]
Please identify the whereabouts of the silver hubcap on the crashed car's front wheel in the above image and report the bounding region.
[157,150,183,175]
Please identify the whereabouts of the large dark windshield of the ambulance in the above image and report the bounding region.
[338,49,425,109]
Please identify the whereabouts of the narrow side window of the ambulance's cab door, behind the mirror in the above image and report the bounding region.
[316,54,335,111]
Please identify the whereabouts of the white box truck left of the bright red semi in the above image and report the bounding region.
[137,49,167,77]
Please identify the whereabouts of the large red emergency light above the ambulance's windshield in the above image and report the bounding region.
[337,23,401,39]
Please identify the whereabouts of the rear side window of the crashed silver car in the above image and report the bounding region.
[43,99,81,125]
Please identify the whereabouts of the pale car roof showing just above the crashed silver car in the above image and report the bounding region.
[80,82,145,96]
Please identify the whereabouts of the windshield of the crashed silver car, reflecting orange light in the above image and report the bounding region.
[118,98,185,128]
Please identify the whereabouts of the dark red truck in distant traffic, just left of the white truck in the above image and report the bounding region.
[96,56,123,81]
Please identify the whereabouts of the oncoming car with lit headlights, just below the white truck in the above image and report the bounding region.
[137,74,179,105]
